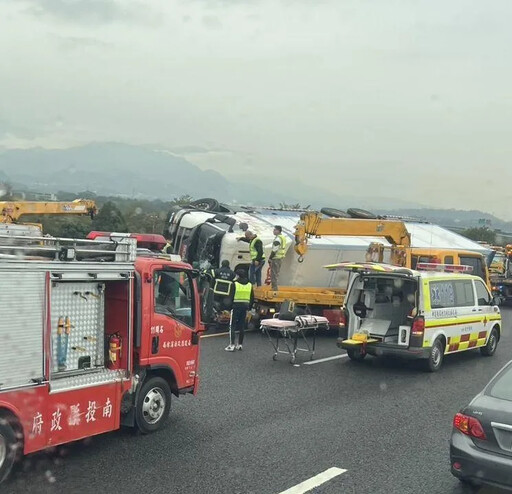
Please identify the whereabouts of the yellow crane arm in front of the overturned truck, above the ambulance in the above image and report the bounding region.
[295,212,411,258]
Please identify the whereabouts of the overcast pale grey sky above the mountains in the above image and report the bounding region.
[0,0,512,219]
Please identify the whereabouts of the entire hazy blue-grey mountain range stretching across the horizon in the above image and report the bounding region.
[0,143,512,232]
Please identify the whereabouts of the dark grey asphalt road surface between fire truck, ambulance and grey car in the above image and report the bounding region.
[7,310,512,494]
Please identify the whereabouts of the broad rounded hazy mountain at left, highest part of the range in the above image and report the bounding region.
[0,143,235,197]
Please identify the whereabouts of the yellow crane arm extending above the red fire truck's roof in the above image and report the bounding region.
[0,199,97,223]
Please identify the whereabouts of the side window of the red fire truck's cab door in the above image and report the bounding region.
[154,271,194,327]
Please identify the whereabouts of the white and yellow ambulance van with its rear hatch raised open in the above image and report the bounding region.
[326,263,501,372]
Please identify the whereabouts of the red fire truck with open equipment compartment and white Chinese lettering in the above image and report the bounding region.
[0,235,203,481]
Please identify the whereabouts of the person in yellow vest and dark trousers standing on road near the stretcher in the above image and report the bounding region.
[225,269,254,352]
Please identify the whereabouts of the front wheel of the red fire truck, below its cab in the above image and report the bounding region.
[135,377,171,434]
